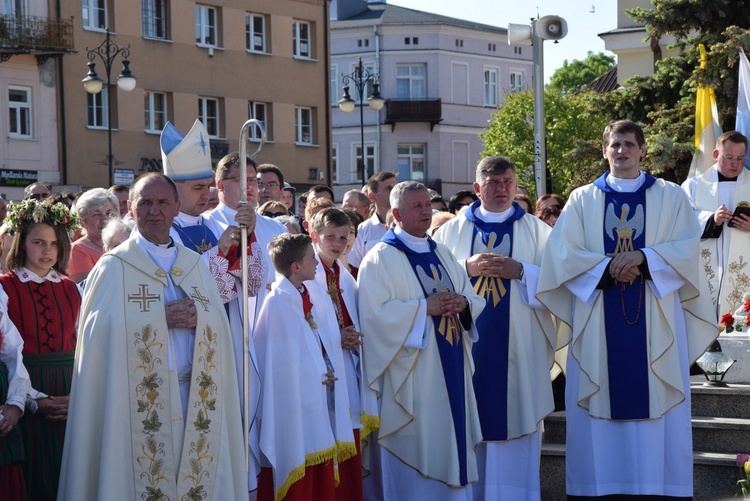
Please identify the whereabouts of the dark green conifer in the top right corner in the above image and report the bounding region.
[598,0,750,182]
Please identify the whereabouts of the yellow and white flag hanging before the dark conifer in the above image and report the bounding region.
[688,44,721,178]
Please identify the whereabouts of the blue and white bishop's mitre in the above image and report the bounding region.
[159,120,214,181]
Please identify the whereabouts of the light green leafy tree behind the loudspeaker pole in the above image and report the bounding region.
[482,88,609,197]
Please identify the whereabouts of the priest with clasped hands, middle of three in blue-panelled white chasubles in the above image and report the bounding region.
[435,157,557,501]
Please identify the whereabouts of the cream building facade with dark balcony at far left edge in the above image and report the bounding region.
[0,0,74,200]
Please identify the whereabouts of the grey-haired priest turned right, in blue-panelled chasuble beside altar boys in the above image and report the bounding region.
[358,182,485,500]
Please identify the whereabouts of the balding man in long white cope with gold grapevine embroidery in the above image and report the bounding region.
[59,173,248,500]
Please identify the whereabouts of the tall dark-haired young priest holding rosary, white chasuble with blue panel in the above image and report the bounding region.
[537,120,718,499]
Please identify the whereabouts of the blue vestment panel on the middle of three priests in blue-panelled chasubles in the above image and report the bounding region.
[465,200,525,441]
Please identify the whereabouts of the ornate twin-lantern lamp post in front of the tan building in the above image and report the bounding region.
[81,28,135,186]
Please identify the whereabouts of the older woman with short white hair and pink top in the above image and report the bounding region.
[68,188,120,282]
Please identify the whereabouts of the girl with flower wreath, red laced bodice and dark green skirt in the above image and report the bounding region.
[0,199,81,499]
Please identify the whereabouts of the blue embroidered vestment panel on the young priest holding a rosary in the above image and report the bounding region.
[594,173,656,420]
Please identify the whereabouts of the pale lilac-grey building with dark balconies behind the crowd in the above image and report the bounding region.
[330,0,532,199]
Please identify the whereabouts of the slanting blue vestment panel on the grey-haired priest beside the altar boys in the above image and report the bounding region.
[381,229,468,485]
